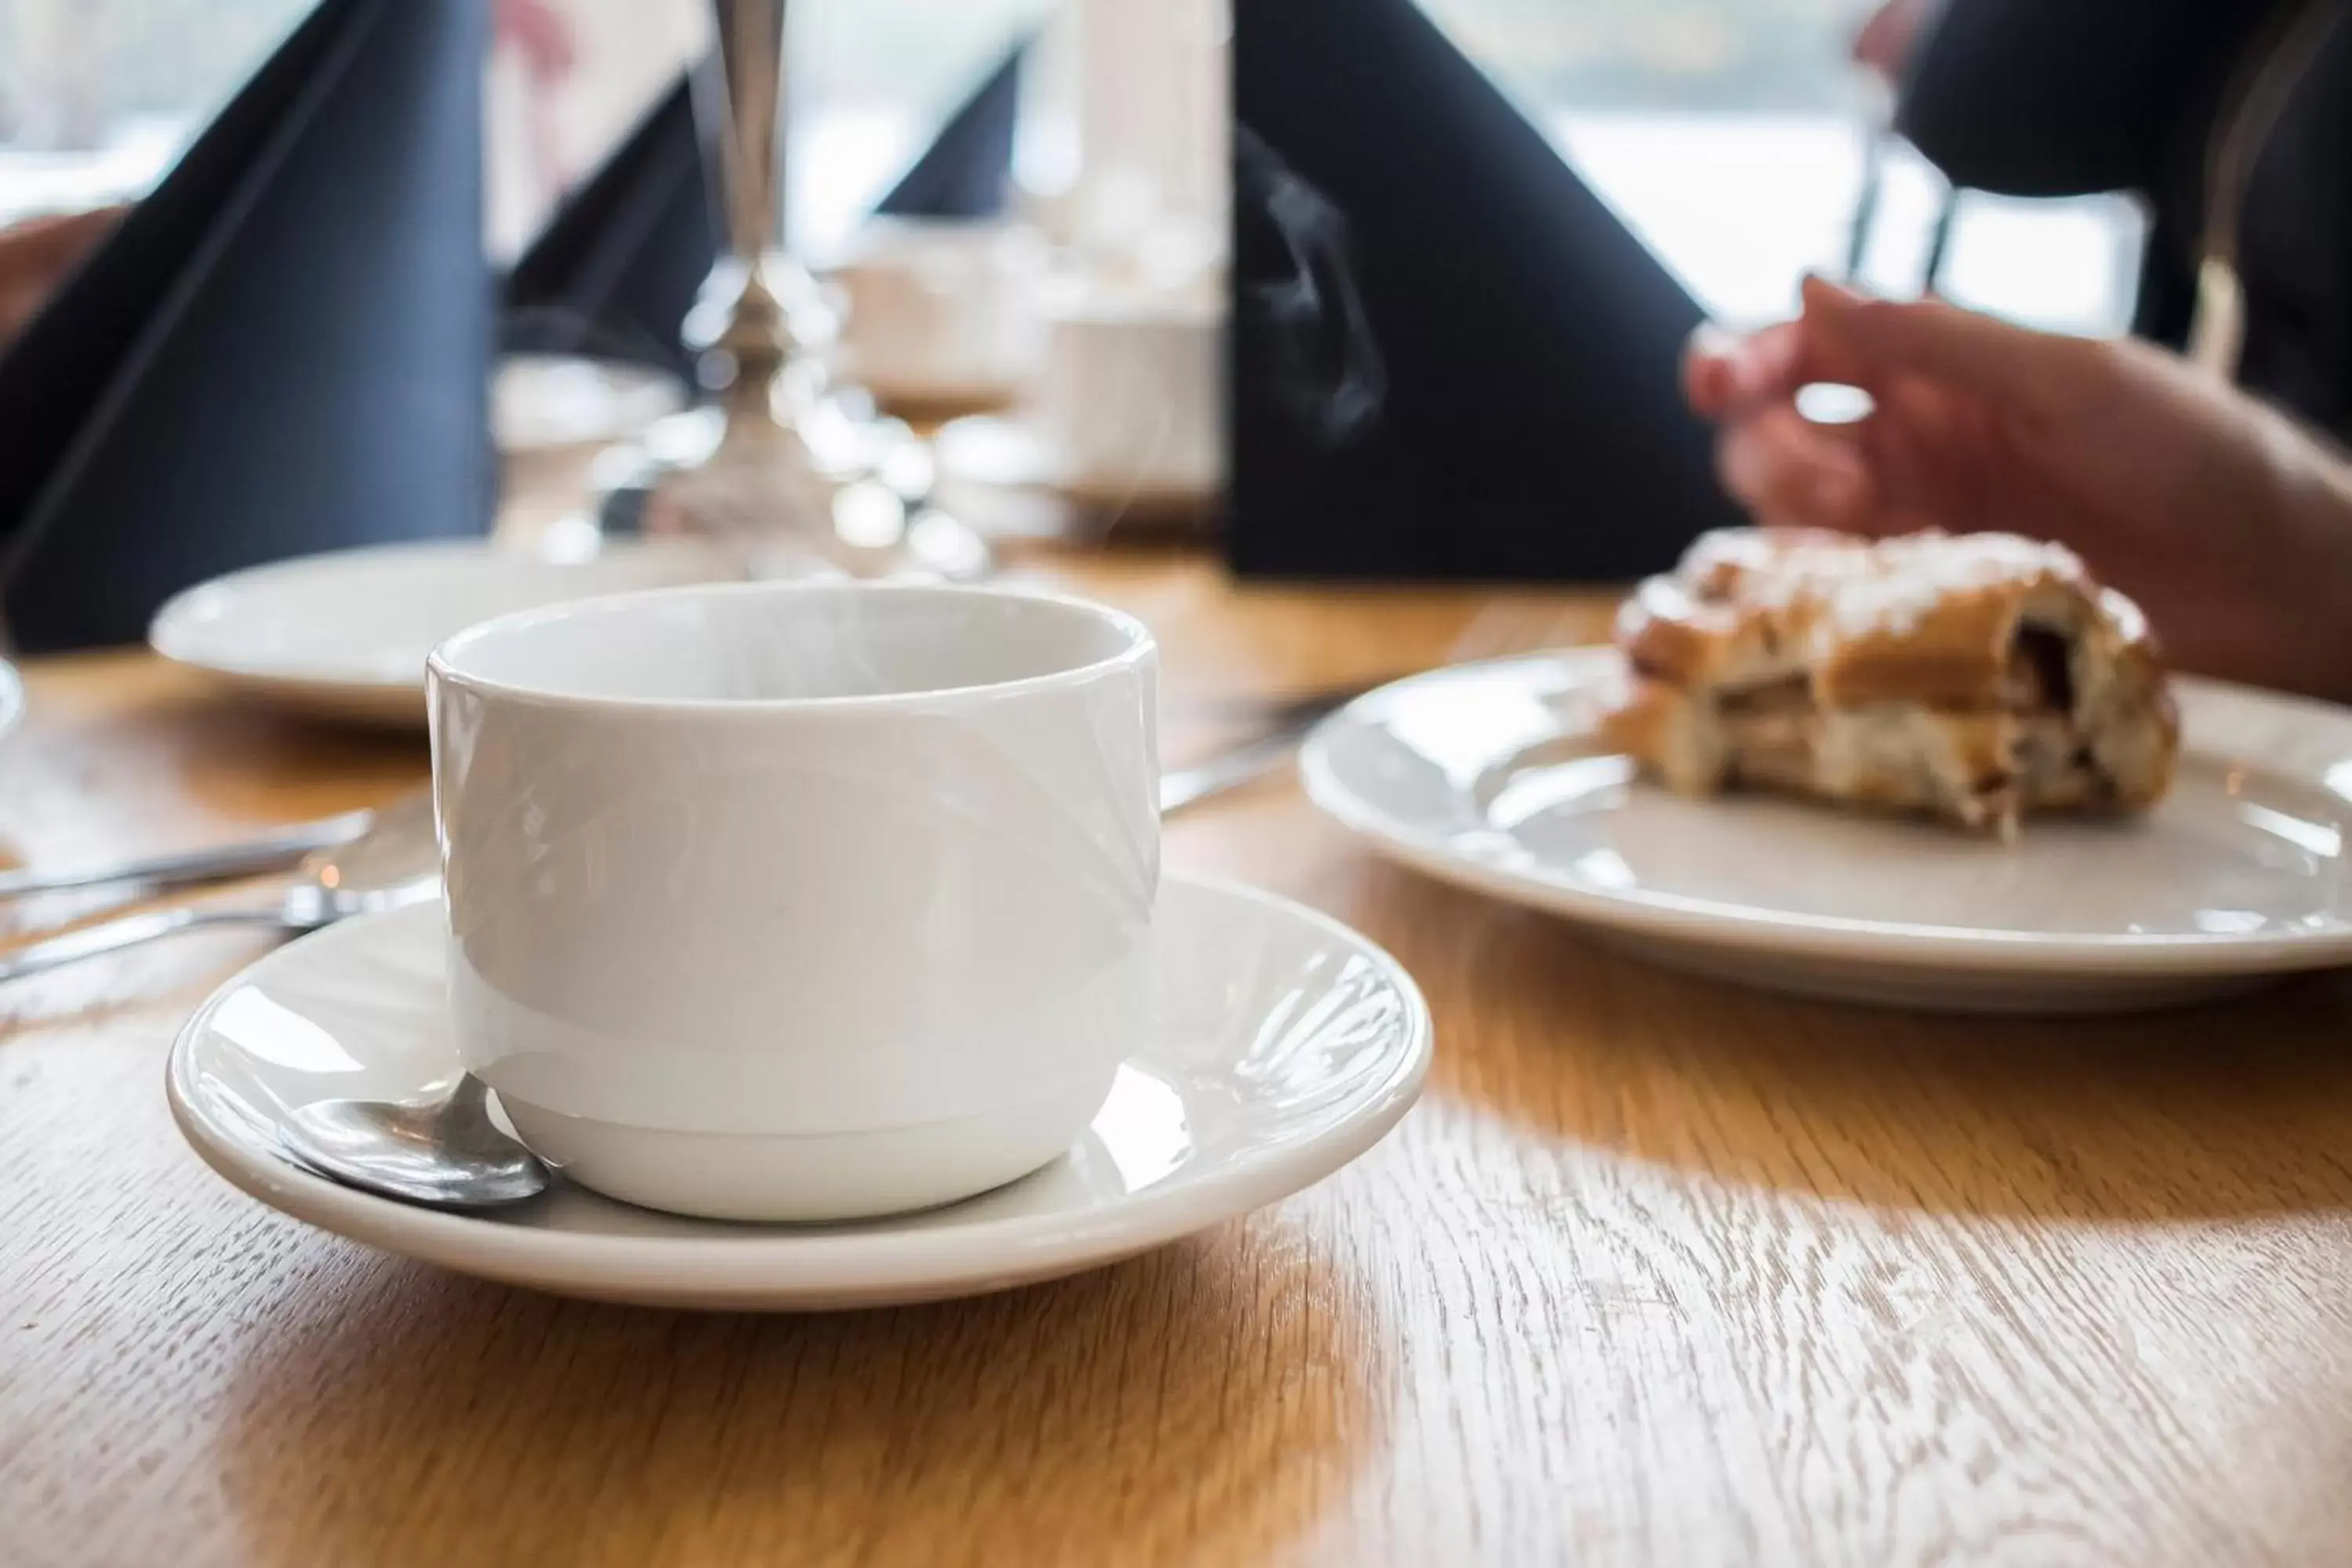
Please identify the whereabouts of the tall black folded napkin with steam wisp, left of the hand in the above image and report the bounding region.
[1225,0,1736,579]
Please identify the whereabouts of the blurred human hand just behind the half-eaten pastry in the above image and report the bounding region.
[1684,280,2352,699]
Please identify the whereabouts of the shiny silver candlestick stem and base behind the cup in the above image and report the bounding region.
[644,0,990,579]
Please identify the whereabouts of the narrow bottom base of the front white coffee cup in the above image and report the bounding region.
[499,1065,1117,1222]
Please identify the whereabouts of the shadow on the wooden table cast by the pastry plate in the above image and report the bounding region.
[1359,865,2352,1220]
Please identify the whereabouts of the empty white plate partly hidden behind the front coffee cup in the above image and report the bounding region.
[148,539,743,729]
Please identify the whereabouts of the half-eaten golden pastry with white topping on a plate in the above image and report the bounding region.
[1602,529,2180,832]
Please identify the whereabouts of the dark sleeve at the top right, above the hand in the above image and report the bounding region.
[1896,0,2272,195]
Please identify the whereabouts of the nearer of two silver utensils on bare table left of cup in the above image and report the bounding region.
[0,794,440,980]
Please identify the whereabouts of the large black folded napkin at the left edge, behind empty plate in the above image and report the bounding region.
[0,0,492,652]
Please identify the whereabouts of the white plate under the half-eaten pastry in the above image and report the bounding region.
[1301,649,2352,1011]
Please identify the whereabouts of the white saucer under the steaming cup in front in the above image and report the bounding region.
[169,879,1430,1312]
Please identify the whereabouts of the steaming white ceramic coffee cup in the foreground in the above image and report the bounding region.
[430,583,1160,1220]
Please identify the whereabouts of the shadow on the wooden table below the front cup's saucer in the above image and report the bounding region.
[221,1218,1388,1566]
